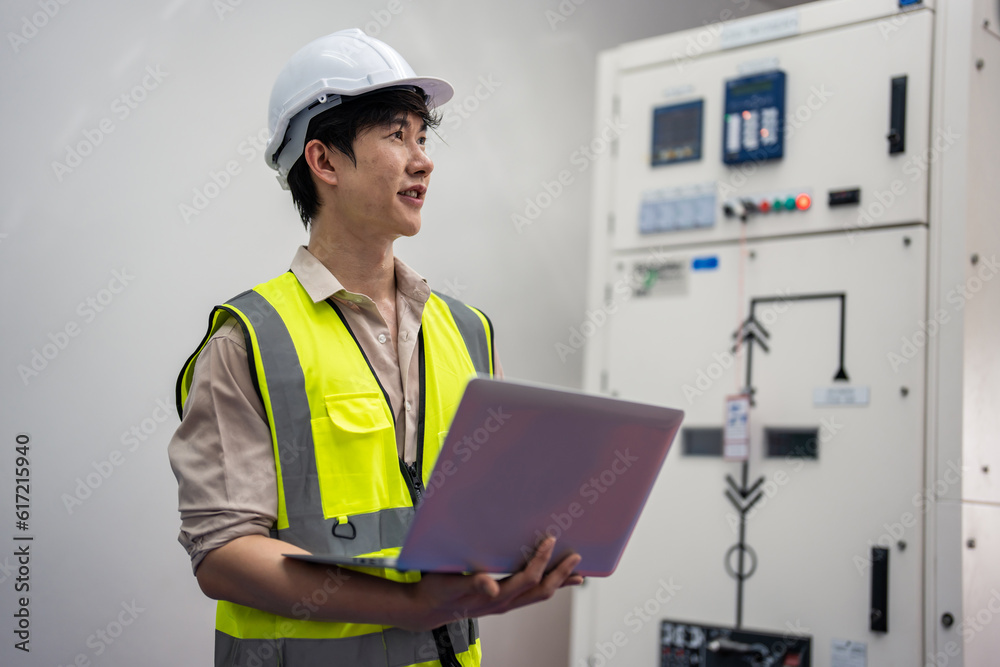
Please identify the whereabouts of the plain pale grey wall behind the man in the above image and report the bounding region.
[0,0,808,665]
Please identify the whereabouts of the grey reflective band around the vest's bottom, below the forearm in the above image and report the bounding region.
[215,621,476,667]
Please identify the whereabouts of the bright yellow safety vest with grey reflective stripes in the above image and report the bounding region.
[177,272,493,667]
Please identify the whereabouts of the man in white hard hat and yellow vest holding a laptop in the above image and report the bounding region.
[169,30,582,667]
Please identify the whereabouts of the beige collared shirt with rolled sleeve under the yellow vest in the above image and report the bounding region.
[167,247,501,571]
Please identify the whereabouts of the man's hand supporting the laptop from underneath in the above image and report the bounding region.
[401,537,583,631]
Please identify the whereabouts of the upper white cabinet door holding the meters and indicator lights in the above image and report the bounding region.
[598,8,932,251]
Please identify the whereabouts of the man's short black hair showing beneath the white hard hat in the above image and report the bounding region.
[288,87,441,230]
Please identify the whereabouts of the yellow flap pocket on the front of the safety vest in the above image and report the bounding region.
[312,392,398,518]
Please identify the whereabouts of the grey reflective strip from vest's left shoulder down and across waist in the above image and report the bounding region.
[229,291,414,557]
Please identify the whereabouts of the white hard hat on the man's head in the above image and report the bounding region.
[264,28,455,189]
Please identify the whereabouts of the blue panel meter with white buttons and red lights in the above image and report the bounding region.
[722,70,785,164]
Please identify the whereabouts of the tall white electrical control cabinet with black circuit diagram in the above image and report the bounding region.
[571,0,992,667]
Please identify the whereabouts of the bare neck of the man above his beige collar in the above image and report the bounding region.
[308,214,396,303]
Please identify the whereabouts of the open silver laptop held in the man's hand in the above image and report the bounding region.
[286,378,684,576]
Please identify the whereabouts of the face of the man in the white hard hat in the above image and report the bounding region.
[331,113,434,241]
